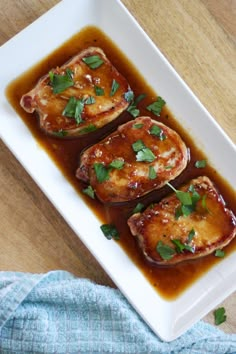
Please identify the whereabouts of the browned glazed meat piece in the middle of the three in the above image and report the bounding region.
[76,117,188,203]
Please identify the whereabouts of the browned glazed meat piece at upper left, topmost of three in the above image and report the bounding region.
[20,47,130,137]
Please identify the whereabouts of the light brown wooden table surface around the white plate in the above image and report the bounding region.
[0,0,236,333]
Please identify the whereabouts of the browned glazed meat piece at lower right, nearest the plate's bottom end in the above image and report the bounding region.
[128,176,236,265]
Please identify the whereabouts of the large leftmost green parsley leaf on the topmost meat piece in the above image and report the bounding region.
[49,68,74,94]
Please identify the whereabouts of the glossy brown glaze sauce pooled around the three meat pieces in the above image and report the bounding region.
[6,27,236,300]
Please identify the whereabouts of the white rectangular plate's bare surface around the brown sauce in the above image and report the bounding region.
[0,0,236,341]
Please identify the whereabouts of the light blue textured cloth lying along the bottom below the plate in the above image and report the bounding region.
[0,271,236,354]
